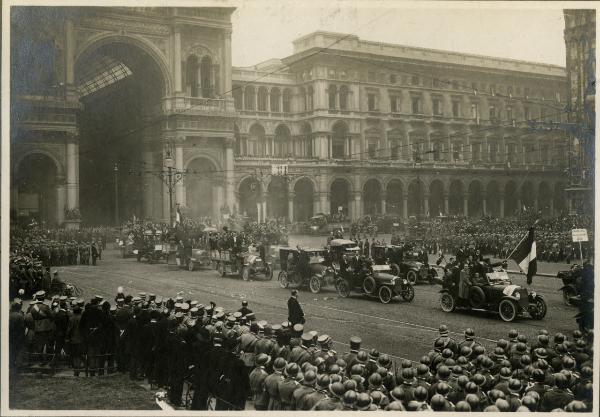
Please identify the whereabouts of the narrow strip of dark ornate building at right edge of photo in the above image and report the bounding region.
[564,9,596,214]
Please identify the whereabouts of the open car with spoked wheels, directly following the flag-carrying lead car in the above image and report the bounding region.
[336,260,415,304]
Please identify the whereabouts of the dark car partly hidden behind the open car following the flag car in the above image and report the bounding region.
[371,245,438,285]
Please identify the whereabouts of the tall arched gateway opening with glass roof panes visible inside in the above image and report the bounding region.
[75,38,166,224]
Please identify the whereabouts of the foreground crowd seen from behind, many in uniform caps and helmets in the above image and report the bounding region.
[9,288,593,412]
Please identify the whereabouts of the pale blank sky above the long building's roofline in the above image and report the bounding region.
[232,0,565,66]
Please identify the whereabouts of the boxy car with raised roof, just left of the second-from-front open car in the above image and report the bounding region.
[277,247,335,294]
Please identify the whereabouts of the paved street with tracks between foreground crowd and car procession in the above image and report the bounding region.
[60,238,576,366]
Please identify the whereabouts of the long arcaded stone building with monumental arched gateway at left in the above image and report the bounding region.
[11,7,568,224]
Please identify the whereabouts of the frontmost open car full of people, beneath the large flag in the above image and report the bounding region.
[440,260,548,322]
